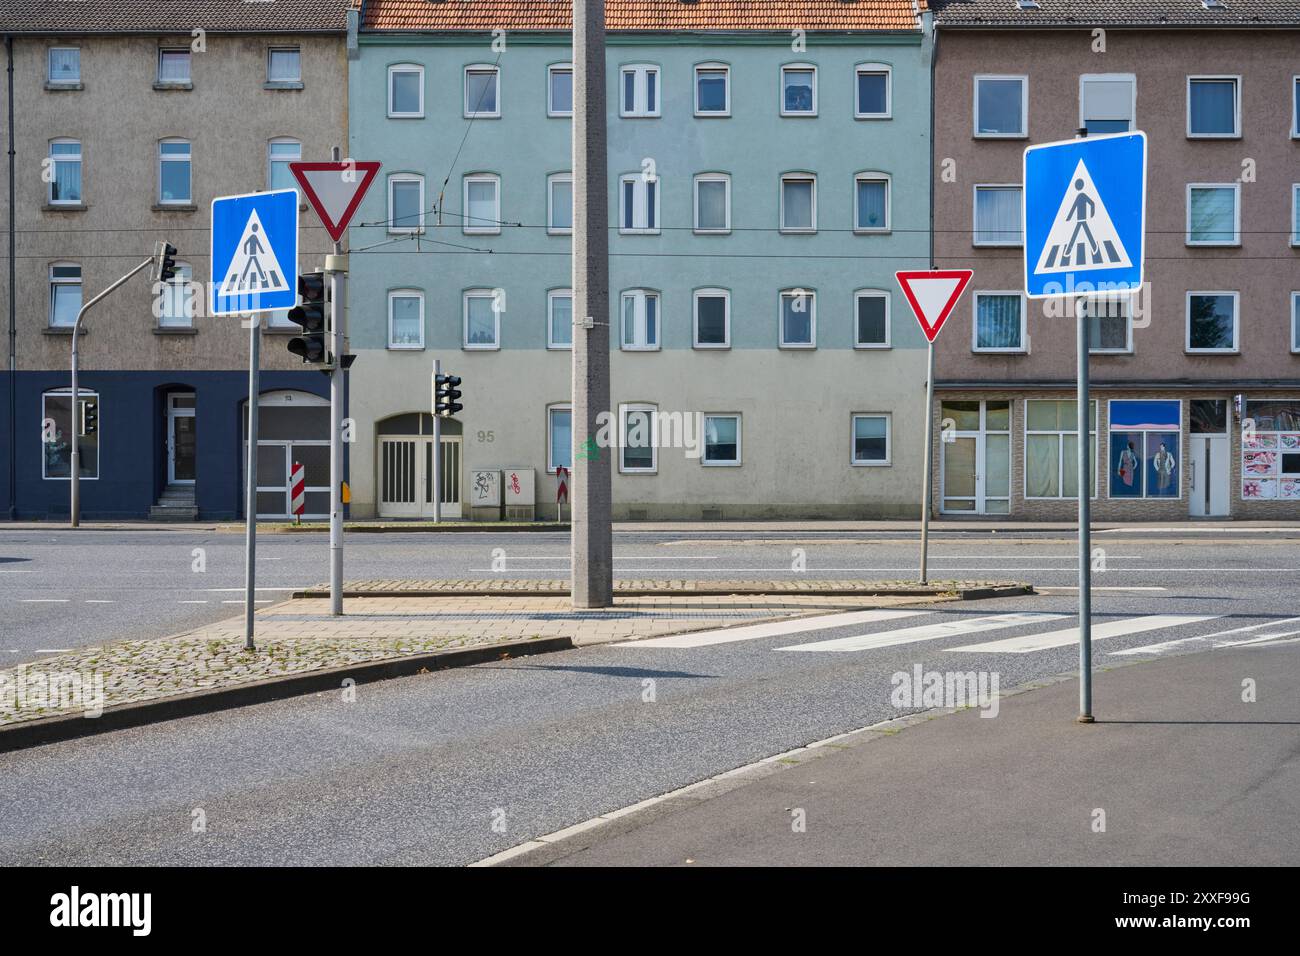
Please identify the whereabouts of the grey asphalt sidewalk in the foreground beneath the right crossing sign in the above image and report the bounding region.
[488,643,1300,868]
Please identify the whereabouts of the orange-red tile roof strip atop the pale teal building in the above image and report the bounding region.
[363,0,920,31]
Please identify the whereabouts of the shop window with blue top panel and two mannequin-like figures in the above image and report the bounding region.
[1108,399,1183,498]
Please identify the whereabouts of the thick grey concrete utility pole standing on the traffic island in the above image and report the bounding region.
[569,0,616,607]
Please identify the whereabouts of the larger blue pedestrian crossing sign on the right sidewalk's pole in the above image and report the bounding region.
[1023,133,1147,299]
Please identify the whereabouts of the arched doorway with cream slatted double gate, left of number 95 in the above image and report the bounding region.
[374,412,462,519]
